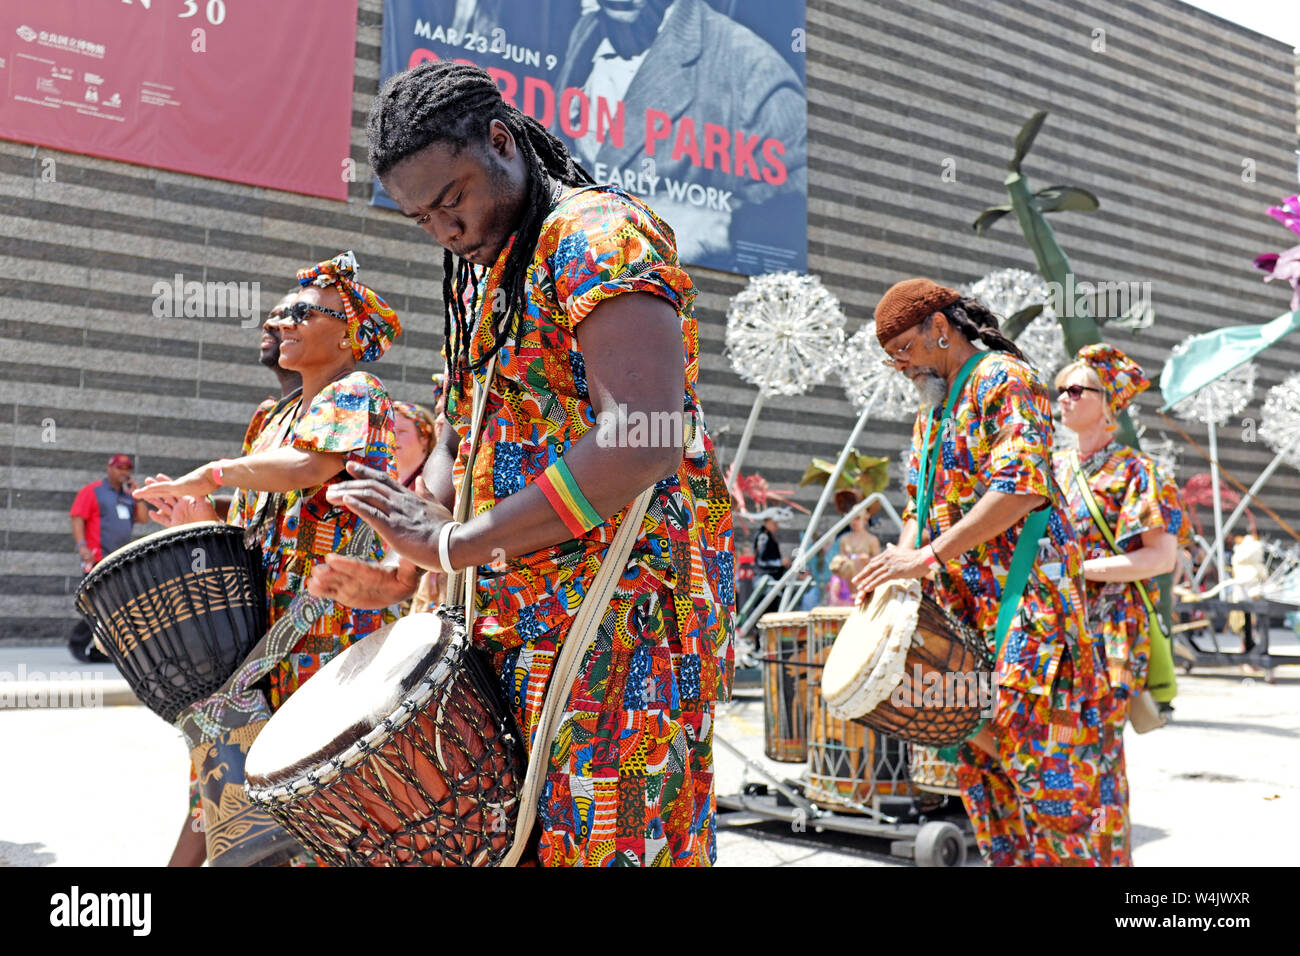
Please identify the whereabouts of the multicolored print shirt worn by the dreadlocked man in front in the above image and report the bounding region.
[447,186,735,701]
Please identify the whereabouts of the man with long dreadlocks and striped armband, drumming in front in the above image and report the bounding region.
[316,62,735,865]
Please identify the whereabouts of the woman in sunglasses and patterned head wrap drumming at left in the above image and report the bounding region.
[135,252,402,865]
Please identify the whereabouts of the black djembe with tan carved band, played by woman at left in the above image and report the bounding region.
[77,522,268,723]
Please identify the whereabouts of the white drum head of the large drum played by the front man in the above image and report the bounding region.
[246,613,459,787]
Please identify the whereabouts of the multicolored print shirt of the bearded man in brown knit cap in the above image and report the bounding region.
[904,351,1108,731]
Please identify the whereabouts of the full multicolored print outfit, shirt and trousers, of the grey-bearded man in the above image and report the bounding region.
[904,351,1109,865]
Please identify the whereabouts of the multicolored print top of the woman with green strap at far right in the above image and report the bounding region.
[1052,441,1187,698]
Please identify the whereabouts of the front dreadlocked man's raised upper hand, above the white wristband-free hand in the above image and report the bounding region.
[325,462,451,571]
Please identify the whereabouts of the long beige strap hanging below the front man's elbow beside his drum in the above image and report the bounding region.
[501,485,654,866]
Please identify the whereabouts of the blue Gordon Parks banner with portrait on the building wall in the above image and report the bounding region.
[374,0,807,274]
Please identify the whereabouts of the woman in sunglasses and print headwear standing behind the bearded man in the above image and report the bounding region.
[1052,343,1183,866]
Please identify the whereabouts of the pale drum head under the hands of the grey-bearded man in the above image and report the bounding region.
[822,580,920,721]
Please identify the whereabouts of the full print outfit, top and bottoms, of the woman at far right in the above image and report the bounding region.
[1052,441,1187,866]
